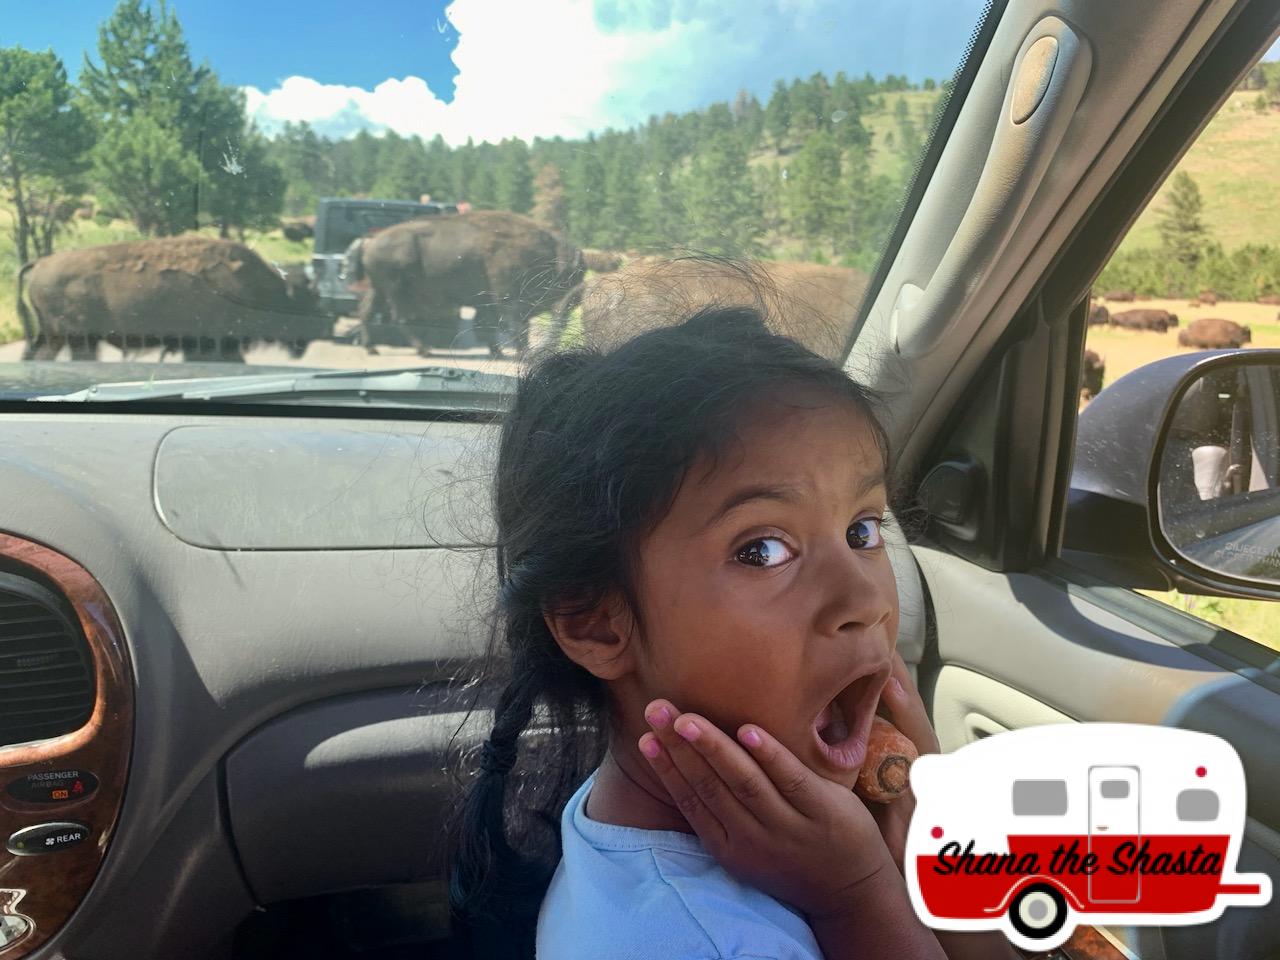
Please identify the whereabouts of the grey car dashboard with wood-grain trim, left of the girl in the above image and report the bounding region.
[0,410,493,960]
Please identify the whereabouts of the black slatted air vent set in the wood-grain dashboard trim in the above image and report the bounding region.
[0,571,95,748]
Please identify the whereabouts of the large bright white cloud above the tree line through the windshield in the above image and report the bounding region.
[246,0,979,145]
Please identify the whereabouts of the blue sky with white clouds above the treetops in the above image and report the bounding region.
[10,0,1280,143]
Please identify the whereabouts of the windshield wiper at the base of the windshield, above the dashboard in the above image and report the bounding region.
[32,366,516,410]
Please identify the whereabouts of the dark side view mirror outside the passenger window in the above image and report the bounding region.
[1062,348,1280,599]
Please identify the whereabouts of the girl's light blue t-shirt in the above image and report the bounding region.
[536,769,822,960]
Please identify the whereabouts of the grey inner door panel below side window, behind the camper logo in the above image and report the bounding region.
[913,543,1280,960]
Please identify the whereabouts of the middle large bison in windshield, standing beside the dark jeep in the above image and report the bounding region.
[360,210,584,356]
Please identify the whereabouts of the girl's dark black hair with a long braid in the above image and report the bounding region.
[448,259,921,957]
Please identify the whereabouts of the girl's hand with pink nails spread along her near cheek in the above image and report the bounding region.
[639,700,892,922]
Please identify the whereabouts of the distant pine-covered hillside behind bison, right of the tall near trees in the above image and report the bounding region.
[268,73,946,266]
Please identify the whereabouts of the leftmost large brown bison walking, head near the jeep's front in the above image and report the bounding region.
[18,236,333,362]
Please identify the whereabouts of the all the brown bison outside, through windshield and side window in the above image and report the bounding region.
[10,211,1280,376]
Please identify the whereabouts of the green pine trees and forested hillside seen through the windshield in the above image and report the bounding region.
[0,0,948,269]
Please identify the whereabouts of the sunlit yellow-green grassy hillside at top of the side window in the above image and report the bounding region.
[1120,91,1280,250]
